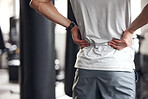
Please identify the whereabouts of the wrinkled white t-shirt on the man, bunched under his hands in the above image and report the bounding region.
[71,0,135,71]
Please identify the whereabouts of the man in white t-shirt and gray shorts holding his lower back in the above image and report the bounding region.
[30,0,148,99]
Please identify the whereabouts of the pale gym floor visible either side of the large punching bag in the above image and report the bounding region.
[0,69,72,99]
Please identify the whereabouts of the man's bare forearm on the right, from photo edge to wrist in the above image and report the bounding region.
[127,4,148,34]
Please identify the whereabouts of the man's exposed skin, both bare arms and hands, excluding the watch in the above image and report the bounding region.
[30,0,148,50]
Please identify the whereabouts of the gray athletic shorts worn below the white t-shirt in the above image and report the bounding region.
[73,69,136,99]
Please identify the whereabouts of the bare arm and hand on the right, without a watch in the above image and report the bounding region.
[109,4,148,50]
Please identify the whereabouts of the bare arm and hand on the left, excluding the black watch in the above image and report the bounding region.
[30,0,89,48]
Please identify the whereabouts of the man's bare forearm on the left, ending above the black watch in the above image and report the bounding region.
[30,0,71,27]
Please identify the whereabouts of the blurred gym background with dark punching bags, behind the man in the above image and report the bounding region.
[0,0,148,99]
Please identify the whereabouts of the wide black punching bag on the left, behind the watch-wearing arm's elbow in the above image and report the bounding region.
[20,0,55,99]
